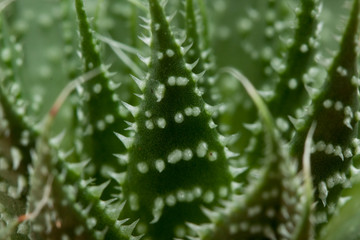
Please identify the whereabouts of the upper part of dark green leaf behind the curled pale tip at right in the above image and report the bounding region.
[268,0,321,124]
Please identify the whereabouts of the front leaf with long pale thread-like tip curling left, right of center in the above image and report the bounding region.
[194,69,312,240]
